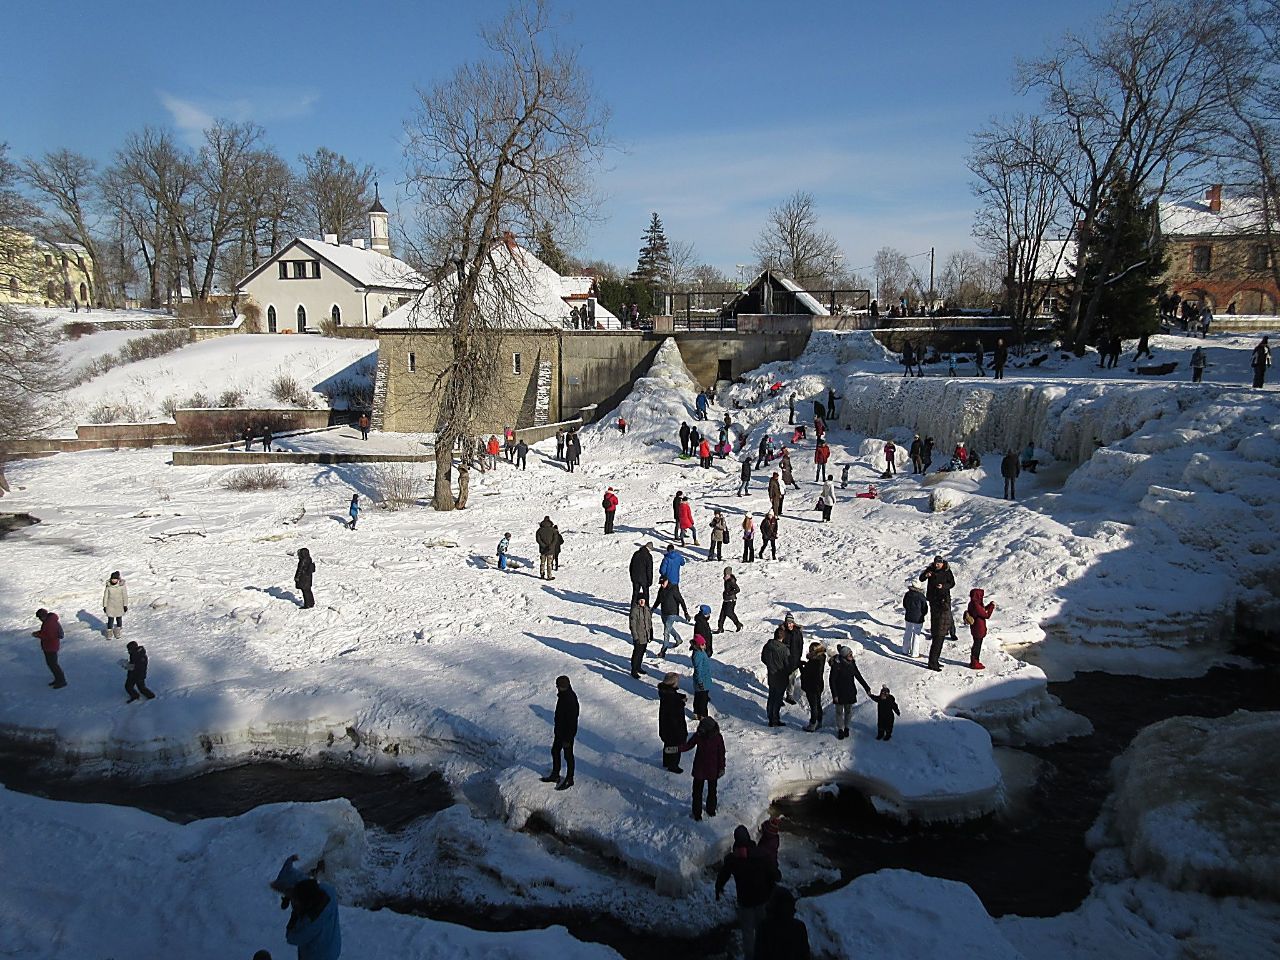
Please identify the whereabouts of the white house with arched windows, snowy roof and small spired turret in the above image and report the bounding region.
[236,196,428,333]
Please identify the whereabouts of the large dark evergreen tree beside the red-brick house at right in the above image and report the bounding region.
[1076,179,1169,337]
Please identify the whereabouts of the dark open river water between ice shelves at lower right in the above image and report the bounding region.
[776,664,1280,916]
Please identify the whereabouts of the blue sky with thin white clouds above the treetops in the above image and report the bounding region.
[0,0,1110,273]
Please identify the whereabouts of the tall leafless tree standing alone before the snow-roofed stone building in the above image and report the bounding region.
[406,0,608,509]
